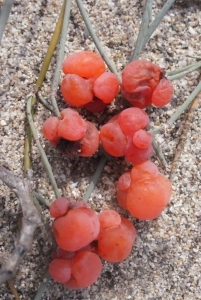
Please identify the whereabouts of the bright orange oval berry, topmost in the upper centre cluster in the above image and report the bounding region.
[62,51,106,78]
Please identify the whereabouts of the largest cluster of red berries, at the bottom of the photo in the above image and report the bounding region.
[49,198,136,289]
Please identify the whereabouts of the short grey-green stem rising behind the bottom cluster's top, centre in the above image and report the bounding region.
[83,155,107,202]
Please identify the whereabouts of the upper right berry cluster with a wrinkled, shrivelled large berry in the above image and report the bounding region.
[121,60,173,108]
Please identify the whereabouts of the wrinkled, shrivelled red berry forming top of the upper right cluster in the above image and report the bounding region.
[122,60,162,93]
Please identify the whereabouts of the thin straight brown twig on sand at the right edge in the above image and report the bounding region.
[170,75,201,181]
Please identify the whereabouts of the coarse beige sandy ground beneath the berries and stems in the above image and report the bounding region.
[0,0,201,300]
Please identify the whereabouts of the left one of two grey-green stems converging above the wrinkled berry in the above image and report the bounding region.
[130,0,153,61]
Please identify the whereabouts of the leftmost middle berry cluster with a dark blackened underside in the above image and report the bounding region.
[42,108,99,156]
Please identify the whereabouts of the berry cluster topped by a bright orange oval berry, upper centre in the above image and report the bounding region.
[61,51,119,112]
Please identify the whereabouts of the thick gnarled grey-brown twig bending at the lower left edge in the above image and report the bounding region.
[0,166,41,284]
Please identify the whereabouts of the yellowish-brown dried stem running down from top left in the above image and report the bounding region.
[24,0,66,176]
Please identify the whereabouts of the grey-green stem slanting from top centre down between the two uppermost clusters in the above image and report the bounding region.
[76,0,121,83]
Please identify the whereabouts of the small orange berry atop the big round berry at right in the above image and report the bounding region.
[130,161,159,184]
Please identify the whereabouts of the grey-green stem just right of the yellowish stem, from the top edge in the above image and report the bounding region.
[51,0,72,118]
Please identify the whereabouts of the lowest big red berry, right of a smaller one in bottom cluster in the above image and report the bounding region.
[71,251,102,288]
